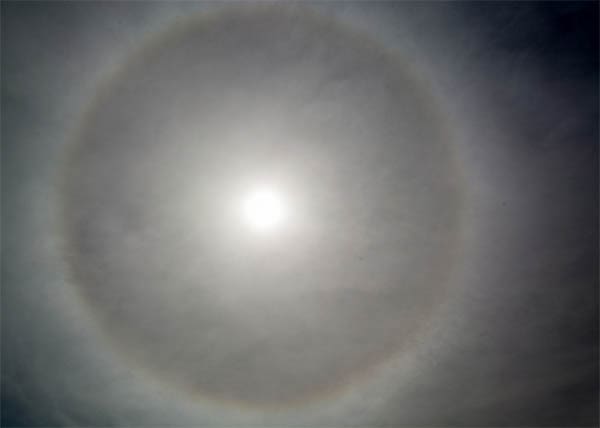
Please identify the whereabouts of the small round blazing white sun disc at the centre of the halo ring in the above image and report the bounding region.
[242,187,286,232]
